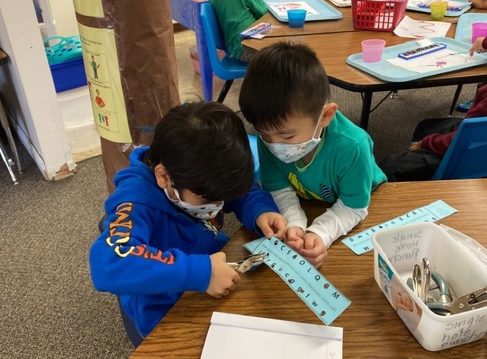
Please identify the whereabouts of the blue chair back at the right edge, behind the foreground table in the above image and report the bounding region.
[432,117,487,179]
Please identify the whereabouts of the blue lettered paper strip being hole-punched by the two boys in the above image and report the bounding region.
[245,238,352,325]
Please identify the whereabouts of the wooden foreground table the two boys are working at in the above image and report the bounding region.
[131,179,487,359]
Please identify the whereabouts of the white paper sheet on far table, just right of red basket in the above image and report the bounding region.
[394,16,451,38]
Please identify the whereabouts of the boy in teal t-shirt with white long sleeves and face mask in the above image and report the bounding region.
[239,43,386,267]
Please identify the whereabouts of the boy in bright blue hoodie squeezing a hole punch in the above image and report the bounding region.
[90,103,286,346]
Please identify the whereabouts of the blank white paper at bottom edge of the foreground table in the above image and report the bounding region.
[201,312,343,359]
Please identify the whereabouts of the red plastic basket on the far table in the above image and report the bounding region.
[352,0,407,31]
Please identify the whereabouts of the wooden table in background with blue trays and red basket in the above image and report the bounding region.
[242,8,487,129]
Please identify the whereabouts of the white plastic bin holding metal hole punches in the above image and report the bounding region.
[373,223,487,351]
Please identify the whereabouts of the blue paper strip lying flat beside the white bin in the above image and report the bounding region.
[342,200,457,255]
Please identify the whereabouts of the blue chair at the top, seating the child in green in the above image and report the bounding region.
[200,2,247,102]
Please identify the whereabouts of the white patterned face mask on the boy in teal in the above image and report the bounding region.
[260,105,326,163]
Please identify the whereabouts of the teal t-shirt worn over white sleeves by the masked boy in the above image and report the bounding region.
[258,111,387,208]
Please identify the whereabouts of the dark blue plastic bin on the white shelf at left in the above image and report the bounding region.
[50,57,86,92]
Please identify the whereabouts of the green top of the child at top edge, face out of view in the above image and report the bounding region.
[210,0,267,59]
